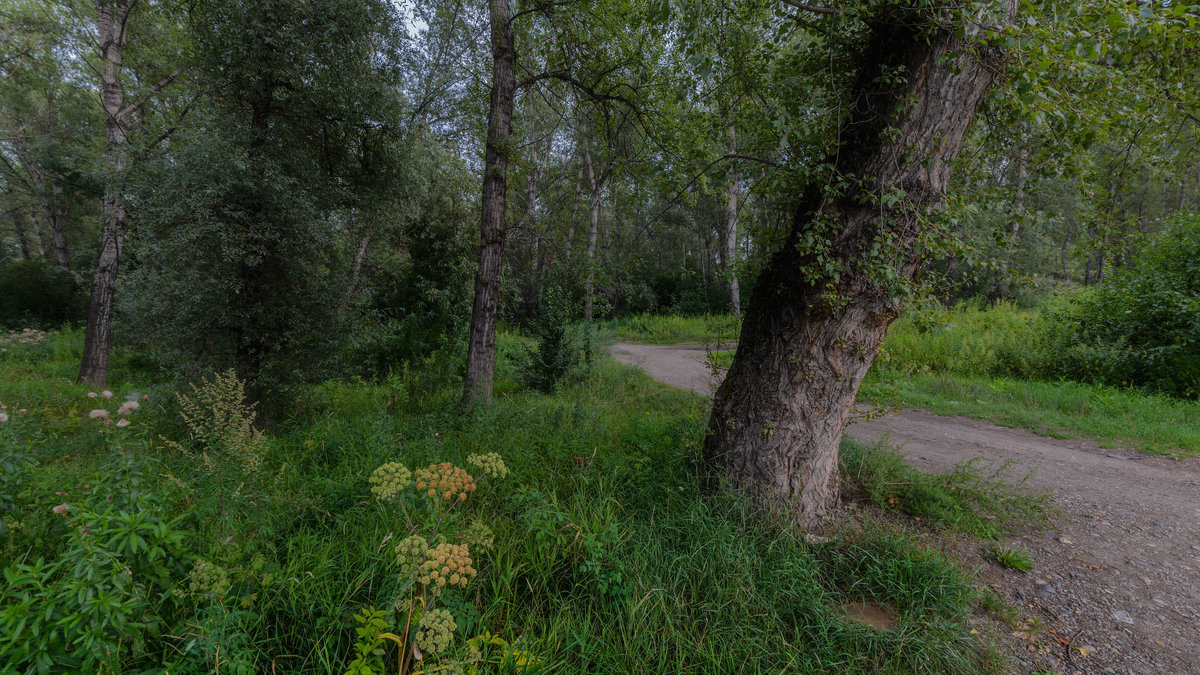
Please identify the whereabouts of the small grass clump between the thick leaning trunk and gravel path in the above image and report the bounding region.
[839,440,1049,539]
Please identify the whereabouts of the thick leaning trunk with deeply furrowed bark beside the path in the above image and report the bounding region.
[704,0,1015,526]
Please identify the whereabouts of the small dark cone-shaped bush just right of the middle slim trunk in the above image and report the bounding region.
[518,287,592,394]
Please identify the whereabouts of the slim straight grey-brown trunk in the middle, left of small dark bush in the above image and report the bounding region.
[463,0,516,405]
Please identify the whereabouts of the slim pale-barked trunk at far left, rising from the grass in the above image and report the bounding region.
[79,0,137,387]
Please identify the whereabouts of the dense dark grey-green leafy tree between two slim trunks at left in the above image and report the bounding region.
[122,0,409,396]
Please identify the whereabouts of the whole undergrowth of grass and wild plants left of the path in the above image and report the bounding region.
[0,331,1022,674]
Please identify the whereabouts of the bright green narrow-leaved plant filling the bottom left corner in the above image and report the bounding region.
[0,455,187,671]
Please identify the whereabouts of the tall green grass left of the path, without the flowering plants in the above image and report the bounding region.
[0,334,1022,674]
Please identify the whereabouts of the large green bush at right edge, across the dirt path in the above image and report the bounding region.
[1050,213,1200,399]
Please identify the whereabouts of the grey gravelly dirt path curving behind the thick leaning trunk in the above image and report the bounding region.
[611,342,1200,675]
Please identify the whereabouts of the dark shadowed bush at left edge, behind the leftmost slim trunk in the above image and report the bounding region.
[0,261,88,328]
